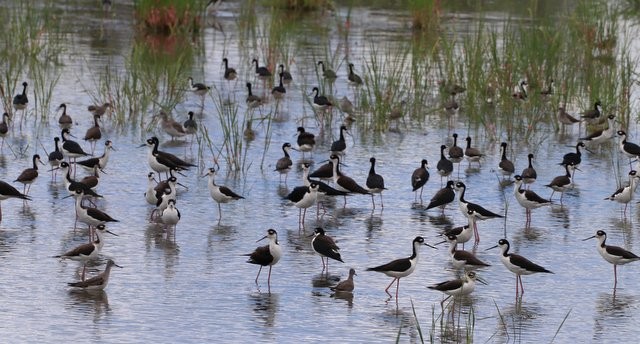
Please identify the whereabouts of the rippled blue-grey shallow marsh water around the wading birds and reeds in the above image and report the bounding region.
[0,1,640,343]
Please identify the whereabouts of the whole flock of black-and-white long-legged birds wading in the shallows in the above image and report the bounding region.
[5,54,640,312]
